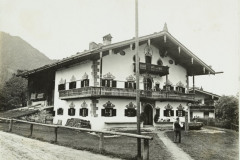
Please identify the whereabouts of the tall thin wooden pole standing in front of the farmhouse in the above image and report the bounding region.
[135,0,141,159]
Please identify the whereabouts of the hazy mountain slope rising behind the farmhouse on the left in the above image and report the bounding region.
[0,32,54,87]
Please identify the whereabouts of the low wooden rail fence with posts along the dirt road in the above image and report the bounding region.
[0,117,153,160]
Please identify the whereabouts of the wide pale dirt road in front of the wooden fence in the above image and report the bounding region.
[0,131,118,160]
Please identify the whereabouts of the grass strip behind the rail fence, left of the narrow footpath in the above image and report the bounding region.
[0,123,171,160]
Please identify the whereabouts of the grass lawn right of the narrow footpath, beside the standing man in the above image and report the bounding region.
[166,127,239,160]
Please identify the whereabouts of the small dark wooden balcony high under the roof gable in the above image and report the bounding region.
[133,63,169,76]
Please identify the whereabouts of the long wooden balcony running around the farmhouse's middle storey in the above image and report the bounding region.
[59,87,194,101]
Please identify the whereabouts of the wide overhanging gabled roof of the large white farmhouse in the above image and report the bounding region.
[19,30,216,77]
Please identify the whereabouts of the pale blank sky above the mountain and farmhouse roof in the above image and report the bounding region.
[0,0,240,95]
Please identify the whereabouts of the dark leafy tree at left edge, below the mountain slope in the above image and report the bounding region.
[0,71,27,110]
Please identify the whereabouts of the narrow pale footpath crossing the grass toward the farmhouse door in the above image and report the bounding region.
[156,131,193,160]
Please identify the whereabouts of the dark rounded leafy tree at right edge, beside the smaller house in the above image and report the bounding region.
[216,96,239,125]
